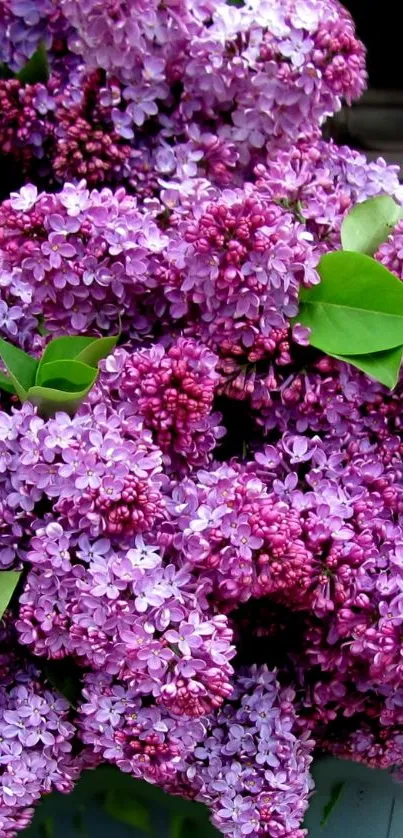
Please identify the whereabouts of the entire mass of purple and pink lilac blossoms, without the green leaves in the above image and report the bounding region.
[0,0,403,838]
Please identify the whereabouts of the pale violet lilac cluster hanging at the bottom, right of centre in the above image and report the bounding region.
[178,666,314,838]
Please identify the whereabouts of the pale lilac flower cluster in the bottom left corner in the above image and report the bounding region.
[0,629,91,838]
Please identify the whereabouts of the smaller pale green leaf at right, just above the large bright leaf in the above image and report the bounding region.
[341,195,403,256]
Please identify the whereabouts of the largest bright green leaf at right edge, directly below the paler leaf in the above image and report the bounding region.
[294,251,403,355]
